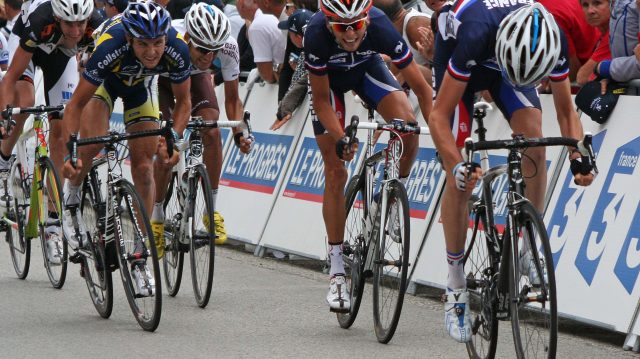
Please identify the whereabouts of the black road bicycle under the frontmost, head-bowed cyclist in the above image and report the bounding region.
[463,103,597,358]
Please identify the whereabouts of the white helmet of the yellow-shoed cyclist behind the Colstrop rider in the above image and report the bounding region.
[184,2,231,51]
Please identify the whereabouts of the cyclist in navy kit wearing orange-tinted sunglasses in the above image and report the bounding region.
[304,0,432,312]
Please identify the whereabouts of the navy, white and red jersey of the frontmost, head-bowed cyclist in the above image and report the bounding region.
[434,0,569,81]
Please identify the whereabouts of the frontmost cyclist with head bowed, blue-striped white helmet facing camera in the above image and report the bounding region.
[428,0,593,342]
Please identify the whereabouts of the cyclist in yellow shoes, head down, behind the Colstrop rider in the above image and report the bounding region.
[151,3,251,257]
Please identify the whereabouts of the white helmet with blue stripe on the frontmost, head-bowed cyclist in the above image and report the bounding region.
[496,3,561,86]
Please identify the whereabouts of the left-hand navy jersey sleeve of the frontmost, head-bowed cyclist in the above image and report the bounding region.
[447,20,495,81]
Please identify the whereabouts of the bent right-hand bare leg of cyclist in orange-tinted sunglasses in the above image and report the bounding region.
[376,91,418,177]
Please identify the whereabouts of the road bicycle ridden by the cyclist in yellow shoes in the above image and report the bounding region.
[162,112,251,308]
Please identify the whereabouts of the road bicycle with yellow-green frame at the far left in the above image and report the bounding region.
[0,106,67,289]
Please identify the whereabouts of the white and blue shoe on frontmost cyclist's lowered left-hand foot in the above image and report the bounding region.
[444,289,471,343]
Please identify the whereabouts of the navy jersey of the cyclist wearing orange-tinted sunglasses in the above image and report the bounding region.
[304,7,413,76]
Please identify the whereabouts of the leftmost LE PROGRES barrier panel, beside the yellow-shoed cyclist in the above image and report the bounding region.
[217,84,304,244]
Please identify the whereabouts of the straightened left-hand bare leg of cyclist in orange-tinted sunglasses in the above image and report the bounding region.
[316,134,347,245]
